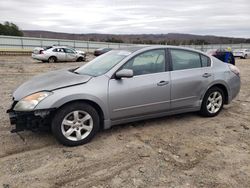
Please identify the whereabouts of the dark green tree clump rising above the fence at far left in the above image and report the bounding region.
[0,22,23,36]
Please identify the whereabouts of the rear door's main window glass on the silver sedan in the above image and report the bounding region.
[170,49,201,70]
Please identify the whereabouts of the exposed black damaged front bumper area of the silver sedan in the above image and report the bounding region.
[7,105,55,133]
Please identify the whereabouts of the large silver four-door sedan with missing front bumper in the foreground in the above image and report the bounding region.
[8,46,240,146]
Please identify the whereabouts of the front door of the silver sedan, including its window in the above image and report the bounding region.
[109,49,170,120]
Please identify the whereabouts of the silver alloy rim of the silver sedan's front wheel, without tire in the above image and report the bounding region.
[61,111,93,141]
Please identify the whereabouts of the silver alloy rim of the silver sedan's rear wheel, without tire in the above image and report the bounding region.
[207,91,222,114]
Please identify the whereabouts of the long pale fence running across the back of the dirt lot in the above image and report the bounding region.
[0,35,250,52]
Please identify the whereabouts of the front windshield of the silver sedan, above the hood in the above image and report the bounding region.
[74,50,131,76]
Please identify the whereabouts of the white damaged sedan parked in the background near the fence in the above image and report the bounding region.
[31,46,86,63]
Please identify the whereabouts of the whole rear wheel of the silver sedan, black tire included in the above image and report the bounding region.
[200,87,225,117]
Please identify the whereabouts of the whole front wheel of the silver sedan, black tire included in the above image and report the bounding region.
[52,102,100,146]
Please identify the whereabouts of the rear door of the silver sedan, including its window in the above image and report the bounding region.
[169,49,213,110]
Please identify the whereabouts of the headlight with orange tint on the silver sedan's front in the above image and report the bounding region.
[14,91,52,111]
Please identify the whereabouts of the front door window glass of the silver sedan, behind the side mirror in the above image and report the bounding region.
[122,49,165,76]
